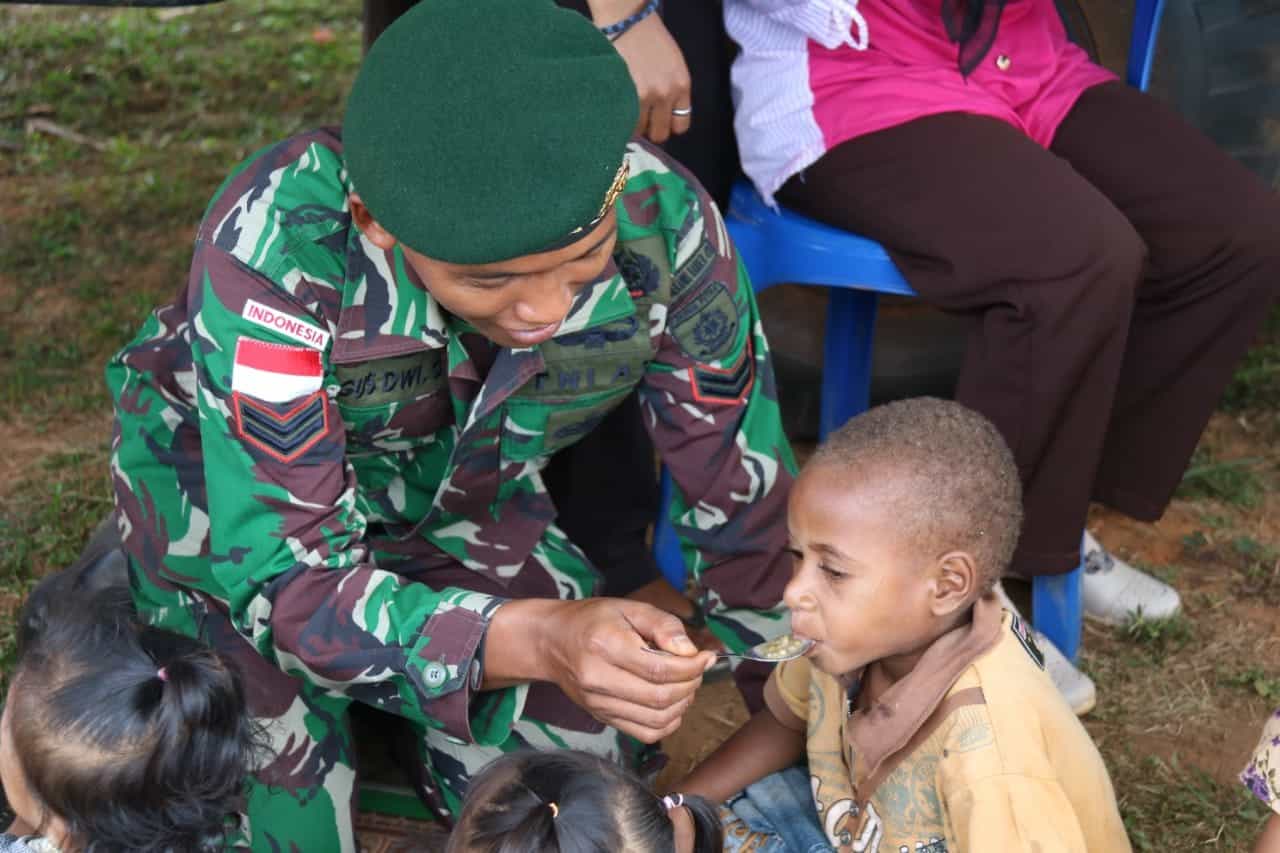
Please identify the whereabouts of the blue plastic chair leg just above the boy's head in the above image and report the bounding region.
[818,287,877,439]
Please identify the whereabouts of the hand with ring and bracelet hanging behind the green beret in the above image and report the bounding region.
[588,0,692,145]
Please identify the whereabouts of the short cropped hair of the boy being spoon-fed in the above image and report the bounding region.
[809,397,1023,590]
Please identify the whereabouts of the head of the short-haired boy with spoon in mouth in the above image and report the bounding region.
[783,397,1021,674]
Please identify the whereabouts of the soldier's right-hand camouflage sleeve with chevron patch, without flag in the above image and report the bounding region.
[641,149,795,710]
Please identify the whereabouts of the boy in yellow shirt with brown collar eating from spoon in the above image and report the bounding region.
[678,398,1130,853]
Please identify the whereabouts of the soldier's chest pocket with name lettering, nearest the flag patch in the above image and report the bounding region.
[335,350,453,456]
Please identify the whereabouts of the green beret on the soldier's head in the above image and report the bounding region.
[342,0,639,264]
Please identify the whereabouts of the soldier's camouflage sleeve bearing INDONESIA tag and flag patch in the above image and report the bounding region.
[181,242,520,744]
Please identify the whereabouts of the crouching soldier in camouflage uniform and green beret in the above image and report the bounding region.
[108,0,794,852]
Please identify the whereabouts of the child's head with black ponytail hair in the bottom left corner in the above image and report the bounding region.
[0,590,256,853]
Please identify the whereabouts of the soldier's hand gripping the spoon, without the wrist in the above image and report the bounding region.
[548,598,716,743]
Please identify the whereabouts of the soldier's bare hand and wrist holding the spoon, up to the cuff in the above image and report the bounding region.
[485,598,716,743]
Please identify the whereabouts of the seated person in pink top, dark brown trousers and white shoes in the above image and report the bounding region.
[726,0,1280,712]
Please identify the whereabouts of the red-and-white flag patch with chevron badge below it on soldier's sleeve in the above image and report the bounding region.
[232,338,329,462]
